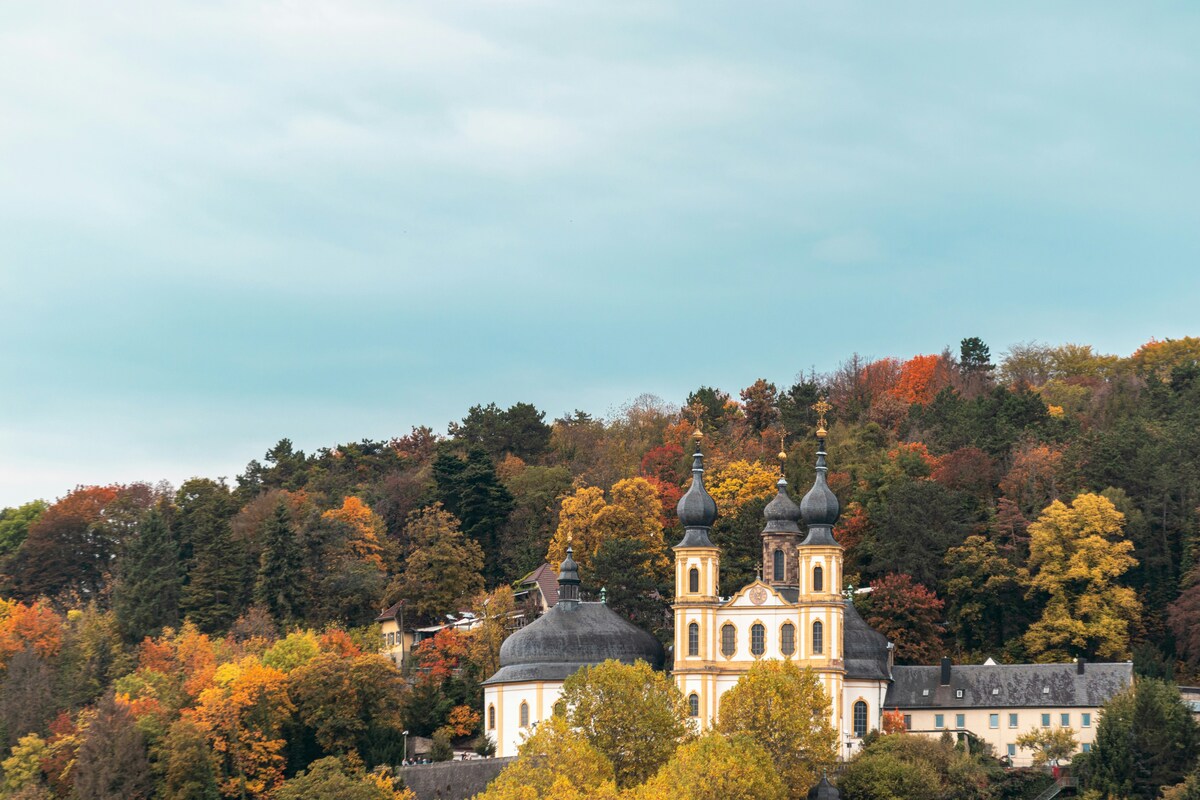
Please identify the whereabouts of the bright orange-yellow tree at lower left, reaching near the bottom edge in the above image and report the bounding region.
[192,656,295,798]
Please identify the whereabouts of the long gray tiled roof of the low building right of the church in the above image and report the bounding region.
[883,661,1133,709]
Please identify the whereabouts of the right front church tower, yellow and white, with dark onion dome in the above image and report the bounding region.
[796,401,846,733]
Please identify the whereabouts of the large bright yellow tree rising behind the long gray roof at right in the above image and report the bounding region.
[1025,494,1141,662]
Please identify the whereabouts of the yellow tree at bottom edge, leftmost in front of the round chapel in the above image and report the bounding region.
[475,716,617,800]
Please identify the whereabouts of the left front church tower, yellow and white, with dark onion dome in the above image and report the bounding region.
[674,431,721,724]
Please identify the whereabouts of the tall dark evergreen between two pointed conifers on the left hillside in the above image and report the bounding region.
[175,479,245,632]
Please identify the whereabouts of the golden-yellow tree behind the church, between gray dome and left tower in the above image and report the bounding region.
[546,477,668,571]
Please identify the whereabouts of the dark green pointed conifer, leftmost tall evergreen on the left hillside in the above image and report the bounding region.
[113,509,181,642]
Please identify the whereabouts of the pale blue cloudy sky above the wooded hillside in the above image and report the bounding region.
[0,0,1200,507]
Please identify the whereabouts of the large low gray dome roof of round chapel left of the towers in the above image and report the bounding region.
[486,602,664,684]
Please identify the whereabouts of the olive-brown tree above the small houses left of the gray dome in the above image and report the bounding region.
[388,504,484,620]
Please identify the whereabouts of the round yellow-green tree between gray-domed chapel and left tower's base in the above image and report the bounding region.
[562,660,691,788]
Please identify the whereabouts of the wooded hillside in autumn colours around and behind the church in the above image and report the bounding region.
[0,337,1200,799]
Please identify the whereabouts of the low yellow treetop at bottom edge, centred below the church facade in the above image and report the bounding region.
[631,732,787,800]
